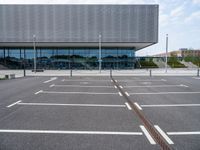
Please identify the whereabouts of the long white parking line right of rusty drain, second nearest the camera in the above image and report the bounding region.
[140,104,200,107]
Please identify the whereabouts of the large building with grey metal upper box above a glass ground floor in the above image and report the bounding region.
[0,5,158,69]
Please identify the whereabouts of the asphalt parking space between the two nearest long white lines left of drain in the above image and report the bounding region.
[0,106,140,132]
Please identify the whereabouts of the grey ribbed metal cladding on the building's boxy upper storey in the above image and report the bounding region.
[0,5,158,48]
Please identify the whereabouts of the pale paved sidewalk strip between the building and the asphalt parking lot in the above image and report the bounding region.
[0,68,197,78]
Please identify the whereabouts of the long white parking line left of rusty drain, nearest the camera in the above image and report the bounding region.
[0,129,142,135]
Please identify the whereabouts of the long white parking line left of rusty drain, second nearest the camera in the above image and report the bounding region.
[17,103,126,108]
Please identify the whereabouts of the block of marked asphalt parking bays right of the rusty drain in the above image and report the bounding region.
[114,77,200,149]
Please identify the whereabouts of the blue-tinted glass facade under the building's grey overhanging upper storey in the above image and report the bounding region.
[0,48,136,69]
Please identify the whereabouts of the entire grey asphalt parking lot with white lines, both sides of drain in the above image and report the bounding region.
[0,76,200,150]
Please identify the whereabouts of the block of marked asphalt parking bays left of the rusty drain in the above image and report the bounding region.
[0,77,159,149]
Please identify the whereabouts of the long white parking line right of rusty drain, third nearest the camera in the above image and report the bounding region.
[129,92,200,95]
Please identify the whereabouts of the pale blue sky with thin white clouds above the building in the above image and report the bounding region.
[0,0,200,56]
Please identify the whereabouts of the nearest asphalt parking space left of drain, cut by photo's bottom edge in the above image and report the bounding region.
[0,133,160,150]
